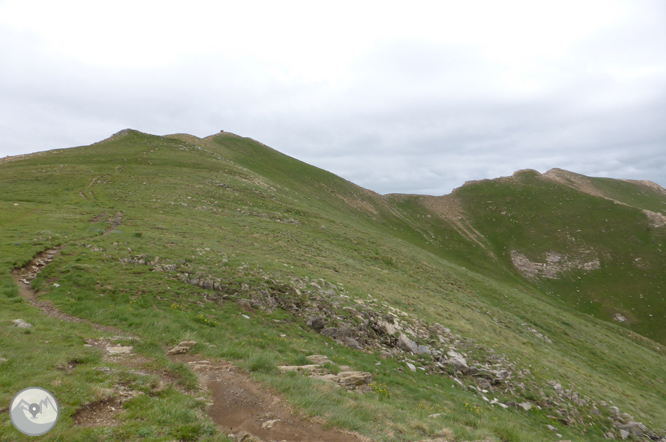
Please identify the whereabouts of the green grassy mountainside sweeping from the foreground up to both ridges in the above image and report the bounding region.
[0,131,666,442]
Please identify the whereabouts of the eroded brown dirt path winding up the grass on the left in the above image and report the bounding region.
[12,245,371,442]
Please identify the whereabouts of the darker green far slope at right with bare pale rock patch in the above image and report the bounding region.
[400,170,666,343]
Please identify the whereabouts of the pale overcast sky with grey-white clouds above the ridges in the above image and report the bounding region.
[0,0,666,195]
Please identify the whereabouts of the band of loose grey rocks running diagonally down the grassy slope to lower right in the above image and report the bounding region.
[131,251,663,440]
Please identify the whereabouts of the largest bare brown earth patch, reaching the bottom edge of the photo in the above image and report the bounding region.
[172,355,370,442]
